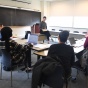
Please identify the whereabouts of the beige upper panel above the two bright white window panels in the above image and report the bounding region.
[50,0,88,16]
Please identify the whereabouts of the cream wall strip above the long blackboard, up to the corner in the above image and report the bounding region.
[0,0,41,11]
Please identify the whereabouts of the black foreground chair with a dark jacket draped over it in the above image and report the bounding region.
[44,66,70,88]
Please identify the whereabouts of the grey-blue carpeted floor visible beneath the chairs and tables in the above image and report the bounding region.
[0,55,87,88]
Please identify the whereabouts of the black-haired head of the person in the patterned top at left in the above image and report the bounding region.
[1,27,12,40]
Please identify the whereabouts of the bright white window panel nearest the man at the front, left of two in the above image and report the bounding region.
[47,16,73,27]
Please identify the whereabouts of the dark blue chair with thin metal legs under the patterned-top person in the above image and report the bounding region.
[1,46,29,87]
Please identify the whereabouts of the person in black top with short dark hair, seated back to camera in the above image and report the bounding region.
[48,31,75,77]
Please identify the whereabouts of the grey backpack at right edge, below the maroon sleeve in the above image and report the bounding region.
[80,49,88,69]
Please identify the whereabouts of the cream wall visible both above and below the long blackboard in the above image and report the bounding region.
[0,0,41,37]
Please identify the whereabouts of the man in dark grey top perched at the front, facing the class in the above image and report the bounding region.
[40,16,51,43]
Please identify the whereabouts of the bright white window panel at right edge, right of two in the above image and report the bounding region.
[73,16,88,28]
